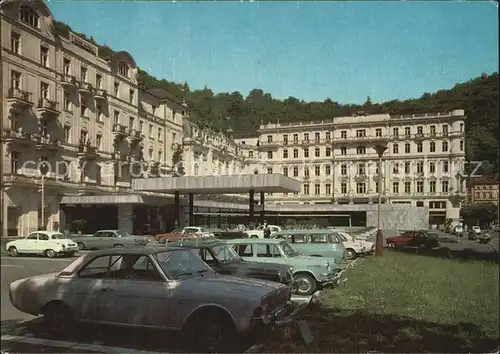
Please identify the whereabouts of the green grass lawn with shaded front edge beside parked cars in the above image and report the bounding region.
[264,251,499,353]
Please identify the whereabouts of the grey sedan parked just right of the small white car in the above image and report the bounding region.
[75,230,148,250]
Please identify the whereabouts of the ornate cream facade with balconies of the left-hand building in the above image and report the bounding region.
[0,1,187,235]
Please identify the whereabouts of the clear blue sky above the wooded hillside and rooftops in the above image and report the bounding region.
[48,1,499,103]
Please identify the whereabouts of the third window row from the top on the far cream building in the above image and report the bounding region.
[267,161,456,177]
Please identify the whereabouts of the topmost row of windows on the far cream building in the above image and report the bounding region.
[267,123,464,145]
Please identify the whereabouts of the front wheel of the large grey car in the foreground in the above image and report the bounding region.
[186,310,237,353]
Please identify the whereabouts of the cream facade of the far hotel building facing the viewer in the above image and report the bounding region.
[237,109,466,219]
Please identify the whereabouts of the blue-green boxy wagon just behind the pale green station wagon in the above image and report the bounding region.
[271,229,346,264]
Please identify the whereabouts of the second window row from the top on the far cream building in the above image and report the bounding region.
[260,140,465,159]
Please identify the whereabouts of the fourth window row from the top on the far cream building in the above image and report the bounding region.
[292,180,456,196]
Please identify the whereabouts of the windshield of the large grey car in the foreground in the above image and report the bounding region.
[154,249,211,280]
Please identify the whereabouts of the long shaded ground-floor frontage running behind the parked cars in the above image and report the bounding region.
[3,188,436,236]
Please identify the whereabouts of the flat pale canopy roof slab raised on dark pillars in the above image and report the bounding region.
[132,174,301,194]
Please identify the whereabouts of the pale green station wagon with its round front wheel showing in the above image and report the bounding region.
[227,238,343,295]
